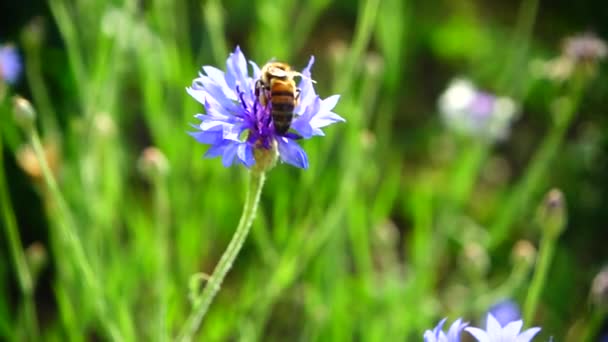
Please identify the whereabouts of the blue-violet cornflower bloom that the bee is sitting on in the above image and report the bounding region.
[186,46,345,169]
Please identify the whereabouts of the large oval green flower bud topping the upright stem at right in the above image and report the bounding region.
[538,189,567,239]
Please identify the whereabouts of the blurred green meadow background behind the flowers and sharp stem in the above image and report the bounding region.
[0,0,608,341]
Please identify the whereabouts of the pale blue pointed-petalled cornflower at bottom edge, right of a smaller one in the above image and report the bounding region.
[465,314,540,342]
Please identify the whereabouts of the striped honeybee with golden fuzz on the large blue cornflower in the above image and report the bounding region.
[255,62,303,135]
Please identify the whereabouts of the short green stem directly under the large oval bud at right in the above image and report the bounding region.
[524,235,556,324]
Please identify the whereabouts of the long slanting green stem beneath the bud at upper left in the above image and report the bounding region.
[28,129,123,341]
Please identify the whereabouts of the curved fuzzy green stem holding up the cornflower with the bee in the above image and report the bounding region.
[178,171,266,341]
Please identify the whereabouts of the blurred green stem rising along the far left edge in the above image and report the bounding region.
[0,123,38,341]
